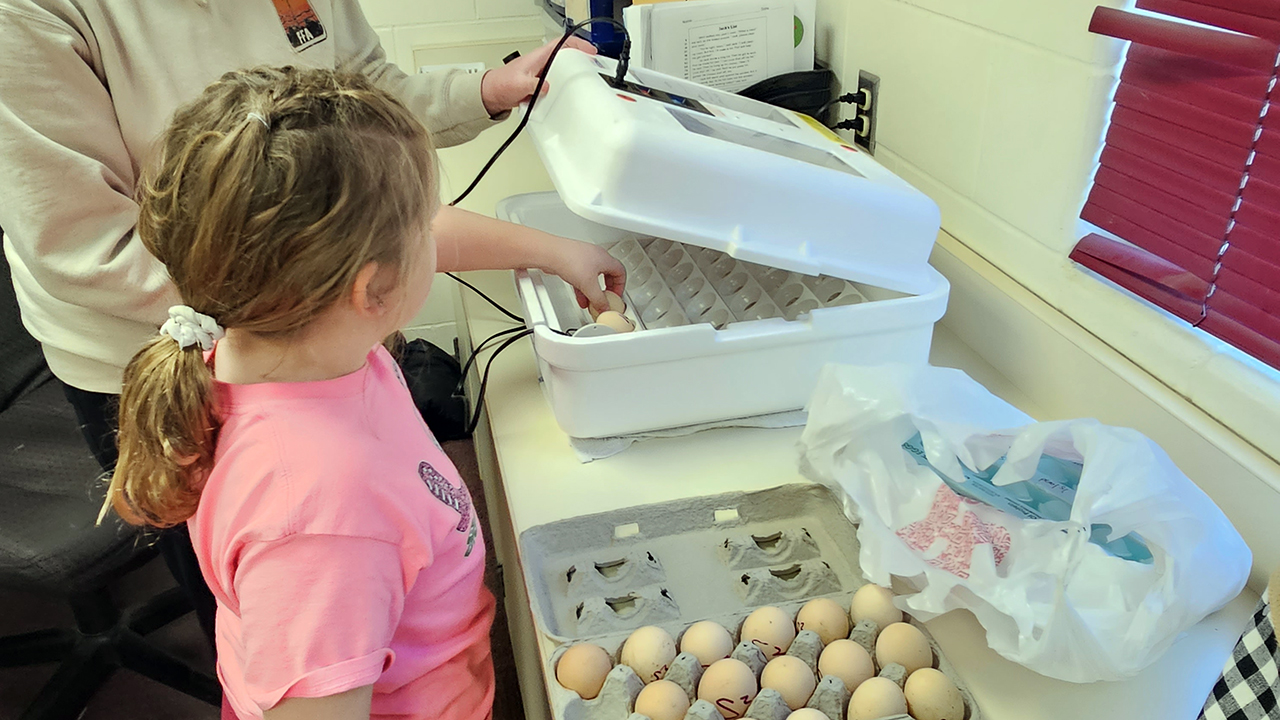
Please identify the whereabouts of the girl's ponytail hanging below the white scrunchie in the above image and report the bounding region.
[102,334,219,528]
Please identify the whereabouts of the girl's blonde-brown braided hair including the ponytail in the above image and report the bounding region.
[104,68,439,527]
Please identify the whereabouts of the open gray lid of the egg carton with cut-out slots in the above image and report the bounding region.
[520,483,865,643]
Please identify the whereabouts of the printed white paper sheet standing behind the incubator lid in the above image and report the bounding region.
[625,0,795,92]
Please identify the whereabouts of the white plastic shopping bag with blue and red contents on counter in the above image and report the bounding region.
[800,365,1252,683]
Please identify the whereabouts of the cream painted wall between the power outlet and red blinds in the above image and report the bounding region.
[842,0,1124,254]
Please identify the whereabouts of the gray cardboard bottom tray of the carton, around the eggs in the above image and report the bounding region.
[544,593,982,720]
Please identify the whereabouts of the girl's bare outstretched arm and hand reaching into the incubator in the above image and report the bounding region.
[431,205,627,310]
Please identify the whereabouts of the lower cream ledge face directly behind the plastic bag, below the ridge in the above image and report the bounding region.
[931,233,1280,592]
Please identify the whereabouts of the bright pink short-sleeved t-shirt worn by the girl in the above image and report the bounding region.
[189,347,494,720]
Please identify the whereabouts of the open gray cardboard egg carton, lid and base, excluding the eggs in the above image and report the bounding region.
[520,483,982,720]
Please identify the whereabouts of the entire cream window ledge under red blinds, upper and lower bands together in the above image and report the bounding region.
[877,147,1280,592]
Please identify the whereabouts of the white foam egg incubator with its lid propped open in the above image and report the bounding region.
[498,51,948,437]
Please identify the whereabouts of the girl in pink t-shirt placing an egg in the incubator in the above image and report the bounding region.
[109,68,622,720]
